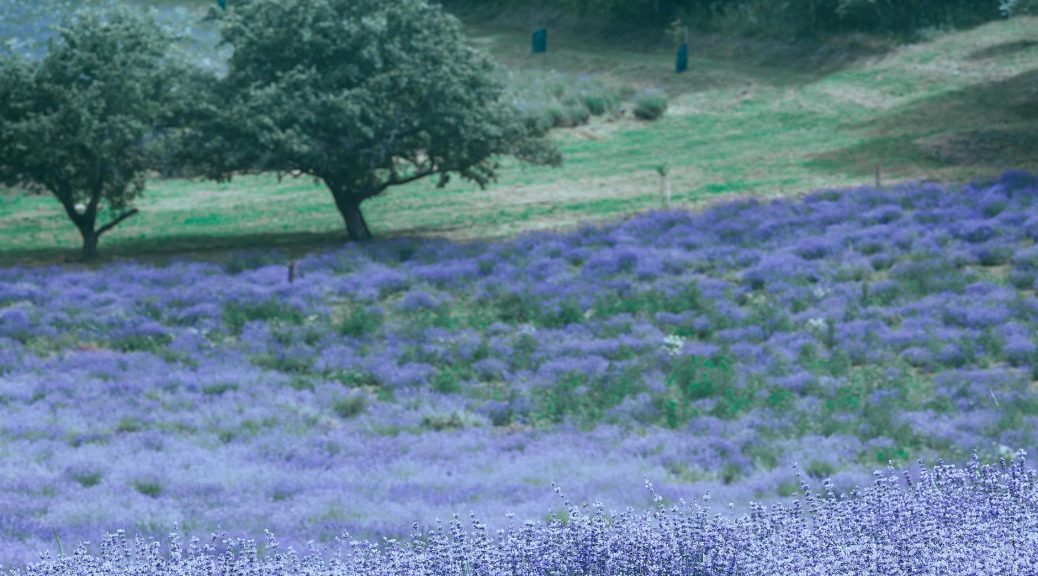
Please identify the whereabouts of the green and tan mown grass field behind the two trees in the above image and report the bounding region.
[0,18,1038,264]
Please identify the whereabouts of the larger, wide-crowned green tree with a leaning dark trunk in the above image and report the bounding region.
[184,0,559,240]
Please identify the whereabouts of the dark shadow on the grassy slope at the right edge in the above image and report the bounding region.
[808,67,1038,177]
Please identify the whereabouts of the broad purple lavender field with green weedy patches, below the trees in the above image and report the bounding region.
[0,172,1038,574]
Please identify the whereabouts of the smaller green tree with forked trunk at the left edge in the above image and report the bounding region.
[0,9,184,259]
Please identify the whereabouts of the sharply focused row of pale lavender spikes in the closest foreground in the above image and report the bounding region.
[12,450,1038,576]
